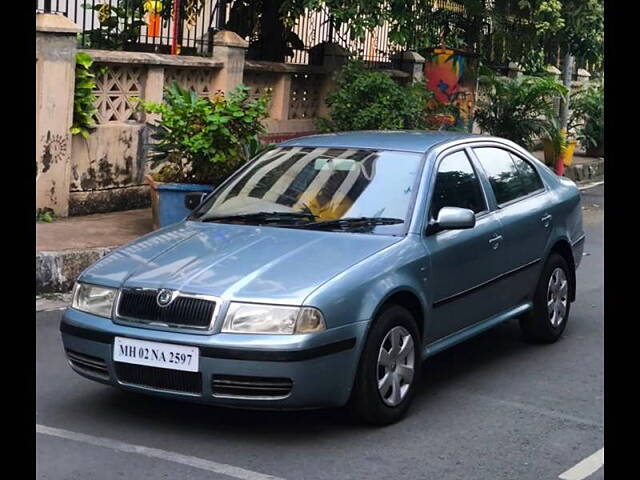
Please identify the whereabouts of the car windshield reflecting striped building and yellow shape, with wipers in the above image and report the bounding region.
[190,147,422,234]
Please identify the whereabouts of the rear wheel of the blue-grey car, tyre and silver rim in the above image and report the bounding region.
[520,252,574,343]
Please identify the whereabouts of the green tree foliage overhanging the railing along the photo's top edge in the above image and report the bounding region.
[220,0,604,72]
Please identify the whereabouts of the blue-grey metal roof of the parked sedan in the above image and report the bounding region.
[278,130,488,153]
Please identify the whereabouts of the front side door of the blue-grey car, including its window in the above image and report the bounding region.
[423,149,505,343]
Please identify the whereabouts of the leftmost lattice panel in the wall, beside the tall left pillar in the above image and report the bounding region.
[94,65,146,124]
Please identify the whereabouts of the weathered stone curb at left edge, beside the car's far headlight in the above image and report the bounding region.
[36,247,117,295]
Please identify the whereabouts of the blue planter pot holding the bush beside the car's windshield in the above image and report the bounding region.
[145,175,214,230]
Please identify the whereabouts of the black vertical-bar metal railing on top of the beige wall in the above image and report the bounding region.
[36,0,464,67]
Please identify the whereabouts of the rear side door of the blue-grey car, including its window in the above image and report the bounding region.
[473,146,554,305]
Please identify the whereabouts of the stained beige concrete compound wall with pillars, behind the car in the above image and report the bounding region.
[36,14,424,216]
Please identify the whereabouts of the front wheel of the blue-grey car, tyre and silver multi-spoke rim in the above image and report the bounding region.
[349,305,422,425]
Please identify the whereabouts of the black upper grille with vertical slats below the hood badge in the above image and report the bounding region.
[117,289,216,329]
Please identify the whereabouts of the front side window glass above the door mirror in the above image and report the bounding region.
[431,150,487,217]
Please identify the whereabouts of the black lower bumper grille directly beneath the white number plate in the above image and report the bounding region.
[115,362,202,395]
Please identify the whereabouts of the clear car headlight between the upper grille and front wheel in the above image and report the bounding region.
[222,302,326,334]
